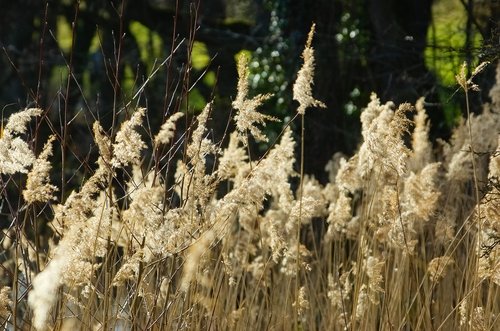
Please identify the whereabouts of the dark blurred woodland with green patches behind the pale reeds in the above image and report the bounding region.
[0,0,500,181]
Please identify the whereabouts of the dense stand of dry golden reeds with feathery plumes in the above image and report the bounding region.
[0,25,500,330]
